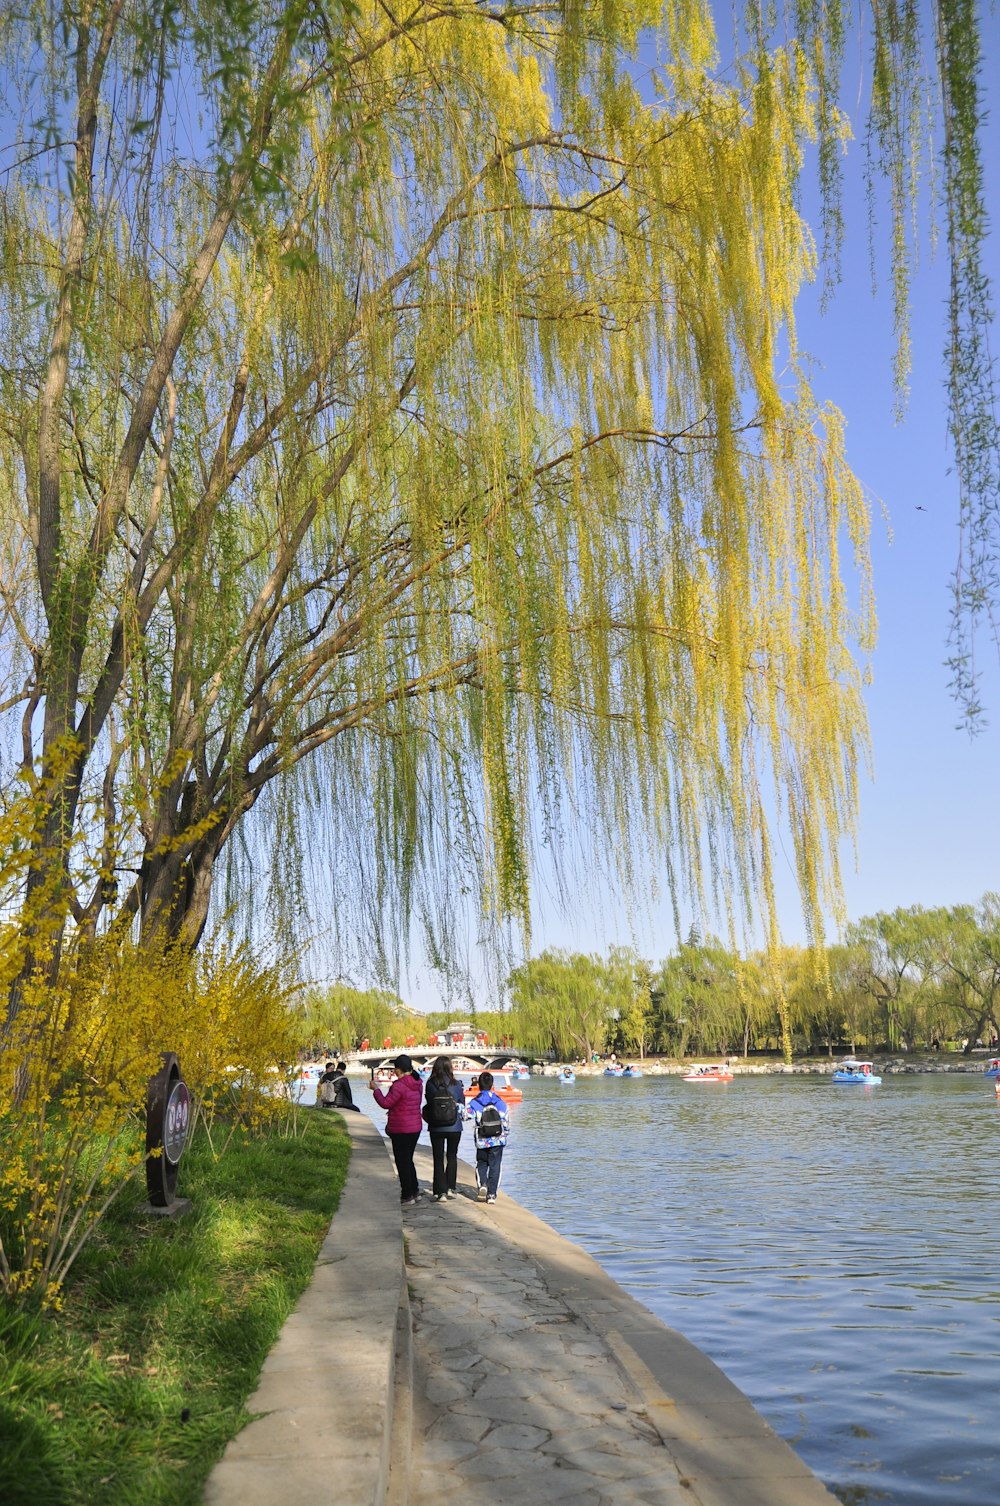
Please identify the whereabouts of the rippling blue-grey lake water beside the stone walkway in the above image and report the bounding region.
[346,1074,1000,1506]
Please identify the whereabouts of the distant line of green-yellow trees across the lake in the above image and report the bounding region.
[304,893,1000,1059]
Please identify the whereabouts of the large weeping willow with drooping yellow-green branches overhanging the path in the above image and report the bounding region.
[0,0,989,1011]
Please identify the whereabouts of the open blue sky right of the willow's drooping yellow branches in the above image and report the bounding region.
[782,17,1000,941]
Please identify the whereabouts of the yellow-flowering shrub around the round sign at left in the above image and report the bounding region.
[0,938,295,1306]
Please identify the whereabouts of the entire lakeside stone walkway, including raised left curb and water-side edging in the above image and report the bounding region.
[205,1114,834,1506]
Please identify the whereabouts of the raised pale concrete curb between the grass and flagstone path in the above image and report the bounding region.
[203,1114,408,1506]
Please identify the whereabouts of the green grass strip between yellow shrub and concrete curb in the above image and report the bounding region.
[0,1110,349,1506]
